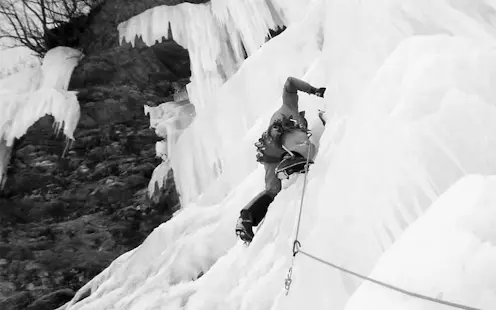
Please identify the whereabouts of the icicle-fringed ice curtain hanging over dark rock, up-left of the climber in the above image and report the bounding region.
[119,0,310,205]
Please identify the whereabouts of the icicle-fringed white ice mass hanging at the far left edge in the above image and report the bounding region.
[0,47,82,184]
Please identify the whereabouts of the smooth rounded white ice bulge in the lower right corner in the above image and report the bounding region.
[345,175,496,310]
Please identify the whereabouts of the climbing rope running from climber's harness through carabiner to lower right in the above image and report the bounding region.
[284,142,482,310]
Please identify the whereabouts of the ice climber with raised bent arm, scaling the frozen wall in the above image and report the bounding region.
[236,77,326,243]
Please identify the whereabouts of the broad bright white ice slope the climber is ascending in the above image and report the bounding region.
[66,0,496,310]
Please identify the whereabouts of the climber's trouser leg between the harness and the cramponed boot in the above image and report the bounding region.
[241,163,282,226]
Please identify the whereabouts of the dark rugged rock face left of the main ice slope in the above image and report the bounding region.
[0,0,197,310]
